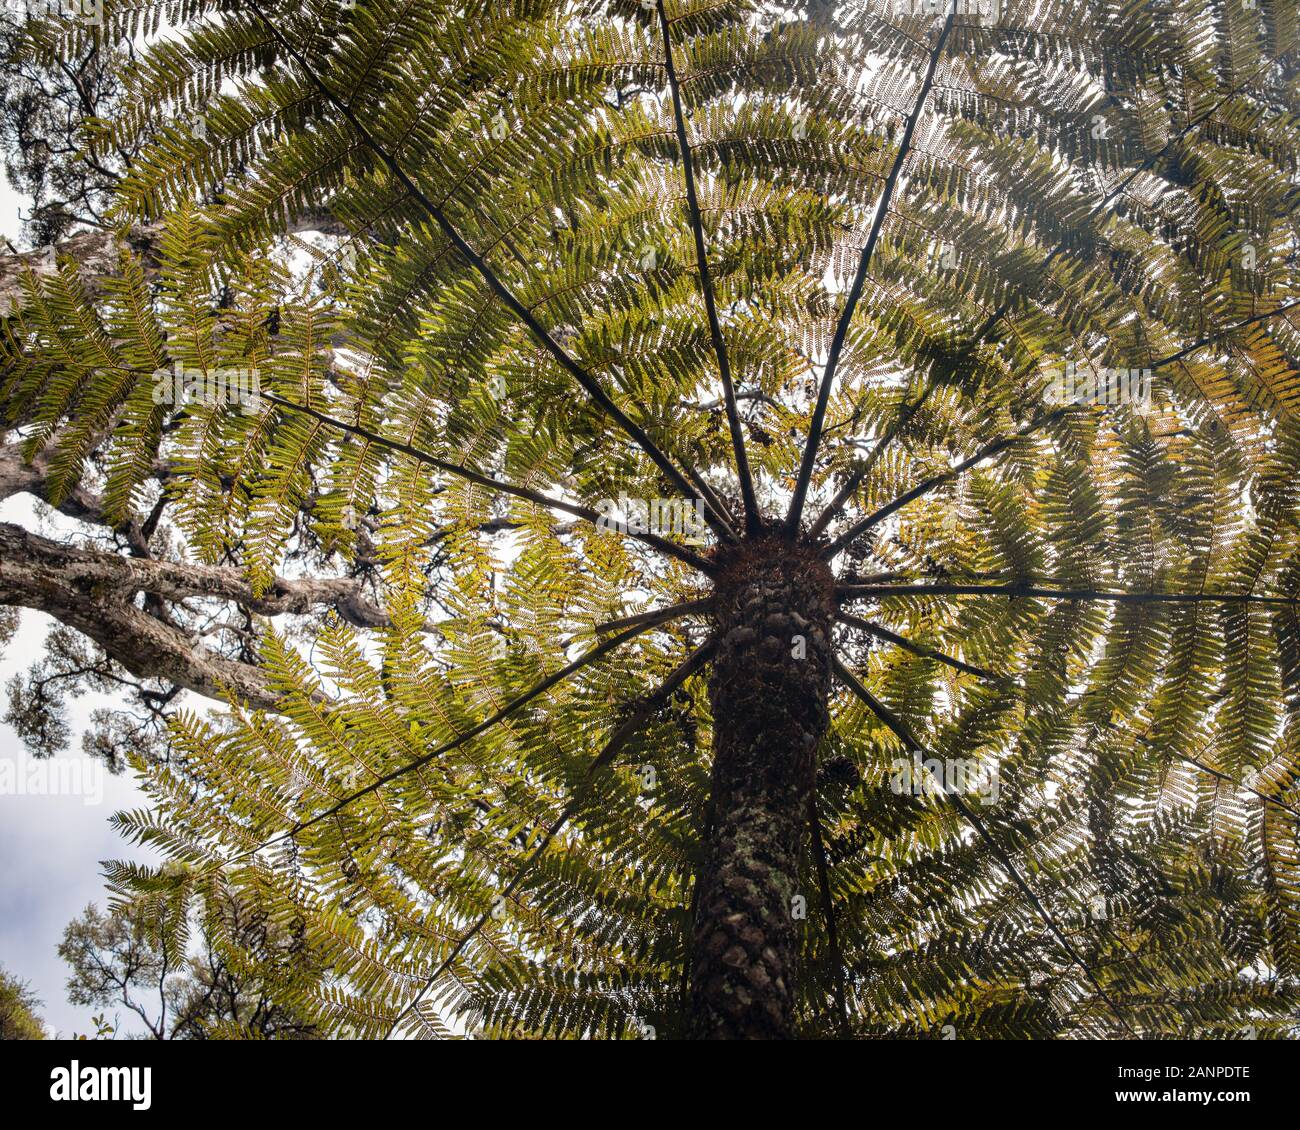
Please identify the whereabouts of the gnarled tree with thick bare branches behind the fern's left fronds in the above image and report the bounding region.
[0,4,366,771]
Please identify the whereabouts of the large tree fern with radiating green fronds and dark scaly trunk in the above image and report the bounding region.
[0,0,1300,1038]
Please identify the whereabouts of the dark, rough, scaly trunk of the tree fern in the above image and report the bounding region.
[690,538,835,1039]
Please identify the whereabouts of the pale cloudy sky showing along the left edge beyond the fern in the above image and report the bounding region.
[0,177,154,1036]
